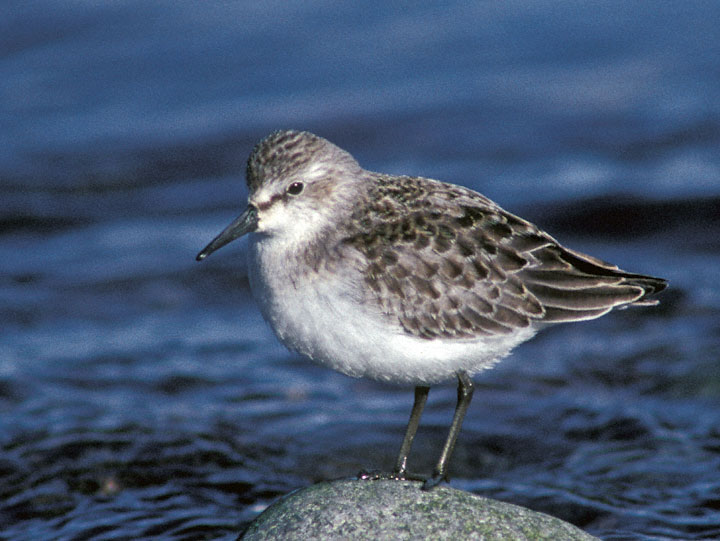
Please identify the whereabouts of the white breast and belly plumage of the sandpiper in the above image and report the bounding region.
[249,239,535,385]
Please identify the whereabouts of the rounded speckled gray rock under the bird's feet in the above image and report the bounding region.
[242,479,596,541]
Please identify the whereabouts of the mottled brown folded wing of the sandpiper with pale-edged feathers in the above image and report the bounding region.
[348,177,665,338]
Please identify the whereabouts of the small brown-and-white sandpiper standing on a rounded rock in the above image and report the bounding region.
[197,131,666,489]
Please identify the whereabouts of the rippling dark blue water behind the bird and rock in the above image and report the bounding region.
[0,0,720,540]
